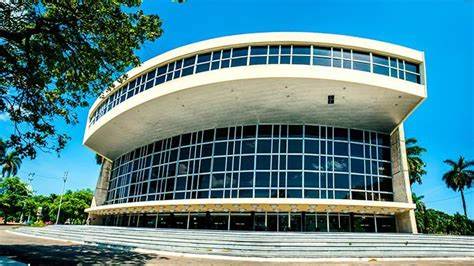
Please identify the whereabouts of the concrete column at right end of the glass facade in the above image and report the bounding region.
[390,124,417,234]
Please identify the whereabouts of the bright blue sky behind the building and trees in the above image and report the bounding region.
[0,0,474,218]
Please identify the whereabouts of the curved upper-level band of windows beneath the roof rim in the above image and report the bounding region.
[89,45,421,126]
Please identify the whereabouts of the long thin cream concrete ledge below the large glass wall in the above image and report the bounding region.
[86,198,416,215]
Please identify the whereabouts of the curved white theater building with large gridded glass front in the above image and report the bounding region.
[84,32,427,233]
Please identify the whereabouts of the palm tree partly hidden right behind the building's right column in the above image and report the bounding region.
[405,138,426,185]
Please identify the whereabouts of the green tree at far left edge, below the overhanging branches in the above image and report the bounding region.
[0,176,31,224]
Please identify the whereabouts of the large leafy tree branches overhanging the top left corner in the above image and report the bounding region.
[0,0,162,158]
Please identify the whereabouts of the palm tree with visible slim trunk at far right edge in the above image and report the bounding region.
[443,156,474,217]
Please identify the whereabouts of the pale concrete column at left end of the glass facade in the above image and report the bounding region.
[88,159,112,224]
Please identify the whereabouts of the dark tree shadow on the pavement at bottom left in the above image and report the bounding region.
[0,244,169,265]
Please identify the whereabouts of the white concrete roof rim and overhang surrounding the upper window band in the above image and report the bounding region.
[84,33,426,159]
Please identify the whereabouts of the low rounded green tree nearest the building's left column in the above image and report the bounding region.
[49,189,93,224]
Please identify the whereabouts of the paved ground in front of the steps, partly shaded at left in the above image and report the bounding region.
[0,226,474,266]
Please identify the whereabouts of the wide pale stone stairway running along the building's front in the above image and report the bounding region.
[14,225,474,259]
